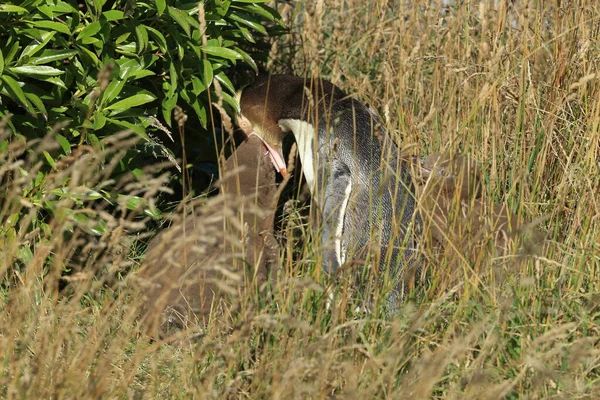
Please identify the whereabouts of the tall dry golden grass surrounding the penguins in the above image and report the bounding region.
[0,0,600,399]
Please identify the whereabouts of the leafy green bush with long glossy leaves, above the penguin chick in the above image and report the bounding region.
[0,0,282,144]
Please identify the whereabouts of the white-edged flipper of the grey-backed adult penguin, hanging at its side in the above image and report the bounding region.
[319,159,352,274]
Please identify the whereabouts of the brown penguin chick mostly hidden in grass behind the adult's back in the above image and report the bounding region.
[412,153,545,260]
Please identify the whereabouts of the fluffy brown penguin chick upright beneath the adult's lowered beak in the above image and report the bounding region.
[134,135,279,339]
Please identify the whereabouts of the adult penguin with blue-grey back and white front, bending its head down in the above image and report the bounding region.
[237,75,421,313]
